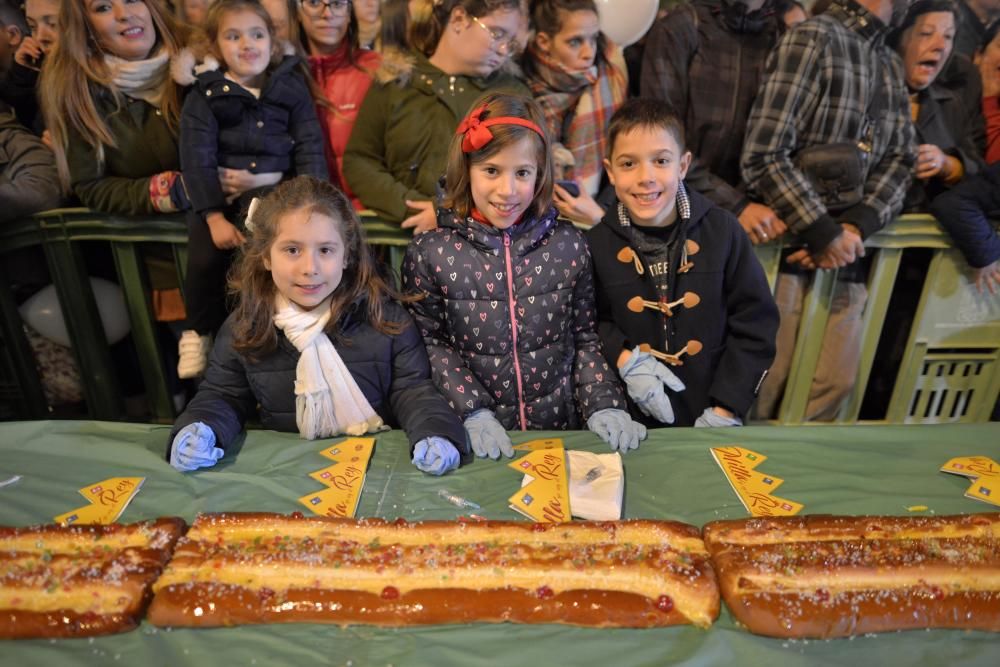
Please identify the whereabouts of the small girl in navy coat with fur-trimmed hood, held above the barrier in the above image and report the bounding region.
[172,0,329,378]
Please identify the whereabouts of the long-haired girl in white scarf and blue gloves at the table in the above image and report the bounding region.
[170,176,469,475]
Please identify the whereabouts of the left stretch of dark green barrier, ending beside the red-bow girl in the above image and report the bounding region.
[0,208,411,422]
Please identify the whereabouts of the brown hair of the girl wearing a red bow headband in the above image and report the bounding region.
[443,93,553,219]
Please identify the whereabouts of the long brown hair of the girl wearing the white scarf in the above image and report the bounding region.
[229,176,406,358]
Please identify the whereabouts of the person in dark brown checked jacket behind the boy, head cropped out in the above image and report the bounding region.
[642,0,785,244]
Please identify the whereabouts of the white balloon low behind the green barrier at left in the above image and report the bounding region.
[19,278,132,347]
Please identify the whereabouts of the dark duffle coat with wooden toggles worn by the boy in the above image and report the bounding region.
[587,185,778,426]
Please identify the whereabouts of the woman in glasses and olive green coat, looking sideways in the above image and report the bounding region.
[344,0,530,233]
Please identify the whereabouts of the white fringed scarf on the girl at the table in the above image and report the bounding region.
[274,293,383,440]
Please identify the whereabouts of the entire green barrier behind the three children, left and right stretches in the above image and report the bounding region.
[0,209,1000,424]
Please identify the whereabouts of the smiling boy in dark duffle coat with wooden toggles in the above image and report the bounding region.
[587,99,778,426]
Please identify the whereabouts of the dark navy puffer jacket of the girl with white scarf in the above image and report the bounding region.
[167,301,471,462]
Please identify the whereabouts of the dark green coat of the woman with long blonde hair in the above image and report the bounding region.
[66,88,181,215]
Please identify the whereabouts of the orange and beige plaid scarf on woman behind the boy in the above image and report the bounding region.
[527,40,628,195]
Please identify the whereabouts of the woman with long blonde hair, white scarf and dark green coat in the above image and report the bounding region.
[41,0,187,215]
